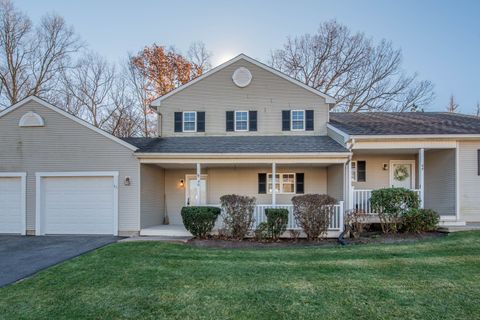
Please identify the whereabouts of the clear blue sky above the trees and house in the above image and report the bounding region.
[13,0,480,113]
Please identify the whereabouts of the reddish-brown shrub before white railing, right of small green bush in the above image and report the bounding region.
[292,194,337,240]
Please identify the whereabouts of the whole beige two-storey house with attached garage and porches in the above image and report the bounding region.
[0,55,480,236]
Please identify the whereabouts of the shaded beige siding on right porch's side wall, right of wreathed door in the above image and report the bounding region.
[424,149,456,216]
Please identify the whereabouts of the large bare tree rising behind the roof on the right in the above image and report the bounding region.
[270,21,434,112]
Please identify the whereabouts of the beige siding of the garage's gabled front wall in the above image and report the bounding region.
[0,101,140,231]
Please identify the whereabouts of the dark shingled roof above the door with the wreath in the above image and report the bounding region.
[329,112,480,136]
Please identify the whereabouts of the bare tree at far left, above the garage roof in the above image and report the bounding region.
[0,0,82,108]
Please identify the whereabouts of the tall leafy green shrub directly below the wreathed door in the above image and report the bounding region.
[370,188,420,233]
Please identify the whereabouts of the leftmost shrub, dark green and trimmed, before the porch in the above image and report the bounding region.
[181,207,221,239]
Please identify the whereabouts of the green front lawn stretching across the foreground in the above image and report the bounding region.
[0,232,480,319]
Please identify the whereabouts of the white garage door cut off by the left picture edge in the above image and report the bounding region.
[0,176,25,234]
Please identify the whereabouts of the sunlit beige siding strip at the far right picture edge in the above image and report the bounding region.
[459,141,480,222]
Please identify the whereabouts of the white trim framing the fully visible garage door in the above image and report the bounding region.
[35,171,119,236]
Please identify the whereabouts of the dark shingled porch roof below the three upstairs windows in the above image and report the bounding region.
[124,136,349,154]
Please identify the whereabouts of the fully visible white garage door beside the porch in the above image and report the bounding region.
[40,176,116,234]
